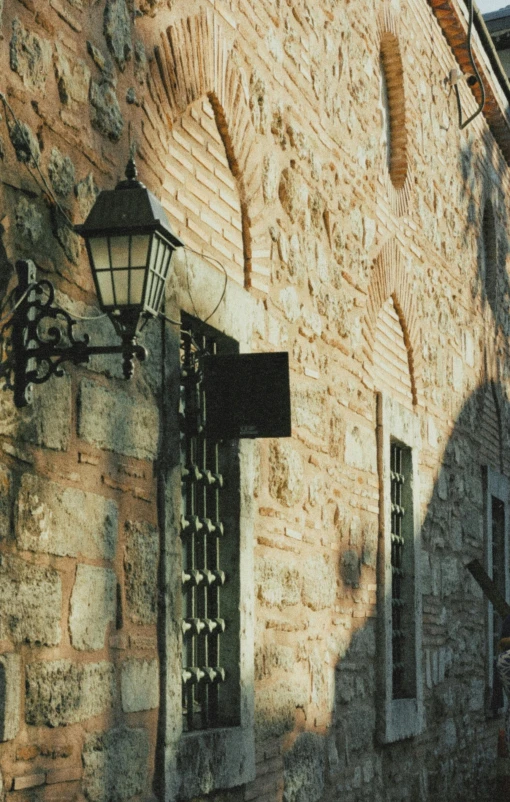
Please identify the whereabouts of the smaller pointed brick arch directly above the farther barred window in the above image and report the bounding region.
[362,240,422,405]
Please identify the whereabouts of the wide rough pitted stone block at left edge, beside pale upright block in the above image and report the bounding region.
[0,555,62,646]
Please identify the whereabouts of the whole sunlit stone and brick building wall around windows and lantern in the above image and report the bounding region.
[0,0,510,802]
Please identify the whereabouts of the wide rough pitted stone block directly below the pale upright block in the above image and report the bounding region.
[25,660,115,727]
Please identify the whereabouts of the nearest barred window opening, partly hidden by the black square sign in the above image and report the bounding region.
[179,316,240,732]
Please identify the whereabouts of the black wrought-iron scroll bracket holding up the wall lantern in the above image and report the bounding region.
[0,260,147,407]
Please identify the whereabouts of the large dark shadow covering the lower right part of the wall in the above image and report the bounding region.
[274,136,510,802]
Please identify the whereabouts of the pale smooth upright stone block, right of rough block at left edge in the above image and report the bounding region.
[69,565,117,650]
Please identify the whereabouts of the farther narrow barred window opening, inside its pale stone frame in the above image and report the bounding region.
[390,442,415,699]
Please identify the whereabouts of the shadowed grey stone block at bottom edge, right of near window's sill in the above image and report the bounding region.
[283,732,326,802]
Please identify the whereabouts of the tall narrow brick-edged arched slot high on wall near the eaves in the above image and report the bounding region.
[377,2,411,216]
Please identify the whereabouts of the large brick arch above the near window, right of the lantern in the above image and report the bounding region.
[146,10,270,287]
